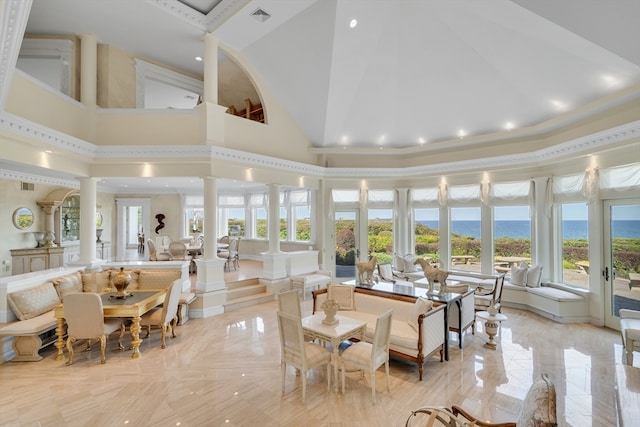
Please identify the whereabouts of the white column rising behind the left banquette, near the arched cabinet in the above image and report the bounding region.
[79,178,98,265]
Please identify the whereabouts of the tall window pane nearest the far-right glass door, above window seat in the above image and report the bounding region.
[560,203,589,288]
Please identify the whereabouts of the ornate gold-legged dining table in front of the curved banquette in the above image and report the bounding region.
[54,289,167,360]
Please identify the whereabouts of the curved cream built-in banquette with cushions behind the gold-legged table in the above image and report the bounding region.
[0,266,190,361]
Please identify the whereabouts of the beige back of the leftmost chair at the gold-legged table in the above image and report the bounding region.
[63,292,104,338]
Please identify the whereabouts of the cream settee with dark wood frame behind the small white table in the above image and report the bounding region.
[312,285,445,381]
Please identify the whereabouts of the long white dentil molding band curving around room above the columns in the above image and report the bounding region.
[0,113,640,182]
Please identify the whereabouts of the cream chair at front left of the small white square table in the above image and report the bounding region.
[278,310,331,402]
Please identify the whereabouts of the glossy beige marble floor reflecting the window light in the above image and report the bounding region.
[0,263,640,427]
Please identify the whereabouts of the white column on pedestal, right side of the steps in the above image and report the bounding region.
[260,184,291,293]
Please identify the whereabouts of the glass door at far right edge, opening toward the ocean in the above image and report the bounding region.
[604,199,640,329]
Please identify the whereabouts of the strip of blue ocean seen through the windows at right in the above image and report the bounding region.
[417,220,640,239]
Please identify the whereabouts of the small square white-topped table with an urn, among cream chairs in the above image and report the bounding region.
[302,313,367,392]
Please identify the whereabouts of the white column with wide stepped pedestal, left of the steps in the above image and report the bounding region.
[189,176,228,318]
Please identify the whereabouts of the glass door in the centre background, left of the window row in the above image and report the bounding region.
[334,210,360,281]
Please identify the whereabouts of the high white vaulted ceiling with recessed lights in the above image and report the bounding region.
[17,0,640,191]
